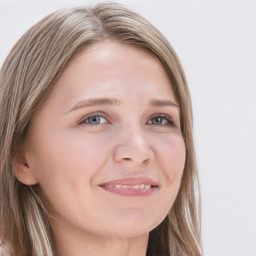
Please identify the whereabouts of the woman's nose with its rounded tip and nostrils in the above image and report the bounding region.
[114,129,154,166]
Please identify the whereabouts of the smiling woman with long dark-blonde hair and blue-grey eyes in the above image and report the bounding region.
[0,3,202,256]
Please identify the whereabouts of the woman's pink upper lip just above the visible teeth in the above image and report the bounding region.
[100,177,159,187]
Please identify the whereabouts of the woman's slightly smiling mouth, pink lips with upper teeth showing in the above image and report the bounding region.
[99,177,159,196]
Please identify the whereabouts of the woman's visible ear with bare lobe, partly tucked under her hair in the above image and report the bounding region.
[12,152,38,185]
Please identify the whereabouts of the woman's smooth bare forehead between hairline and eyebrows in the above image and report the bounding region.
[40,41,175,110]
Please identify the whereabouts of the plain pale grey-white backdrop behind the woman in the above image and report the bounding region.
[0,0,256,256]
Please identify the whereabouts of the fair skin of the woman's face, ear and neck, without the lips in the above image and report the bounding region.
[16,41,185,256]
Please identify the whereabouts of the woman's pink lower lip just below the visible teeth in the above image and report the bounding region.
[100,186,157,196]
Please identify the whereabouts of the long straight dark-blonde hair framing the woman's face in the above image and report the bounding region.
[0,3,203,256]
